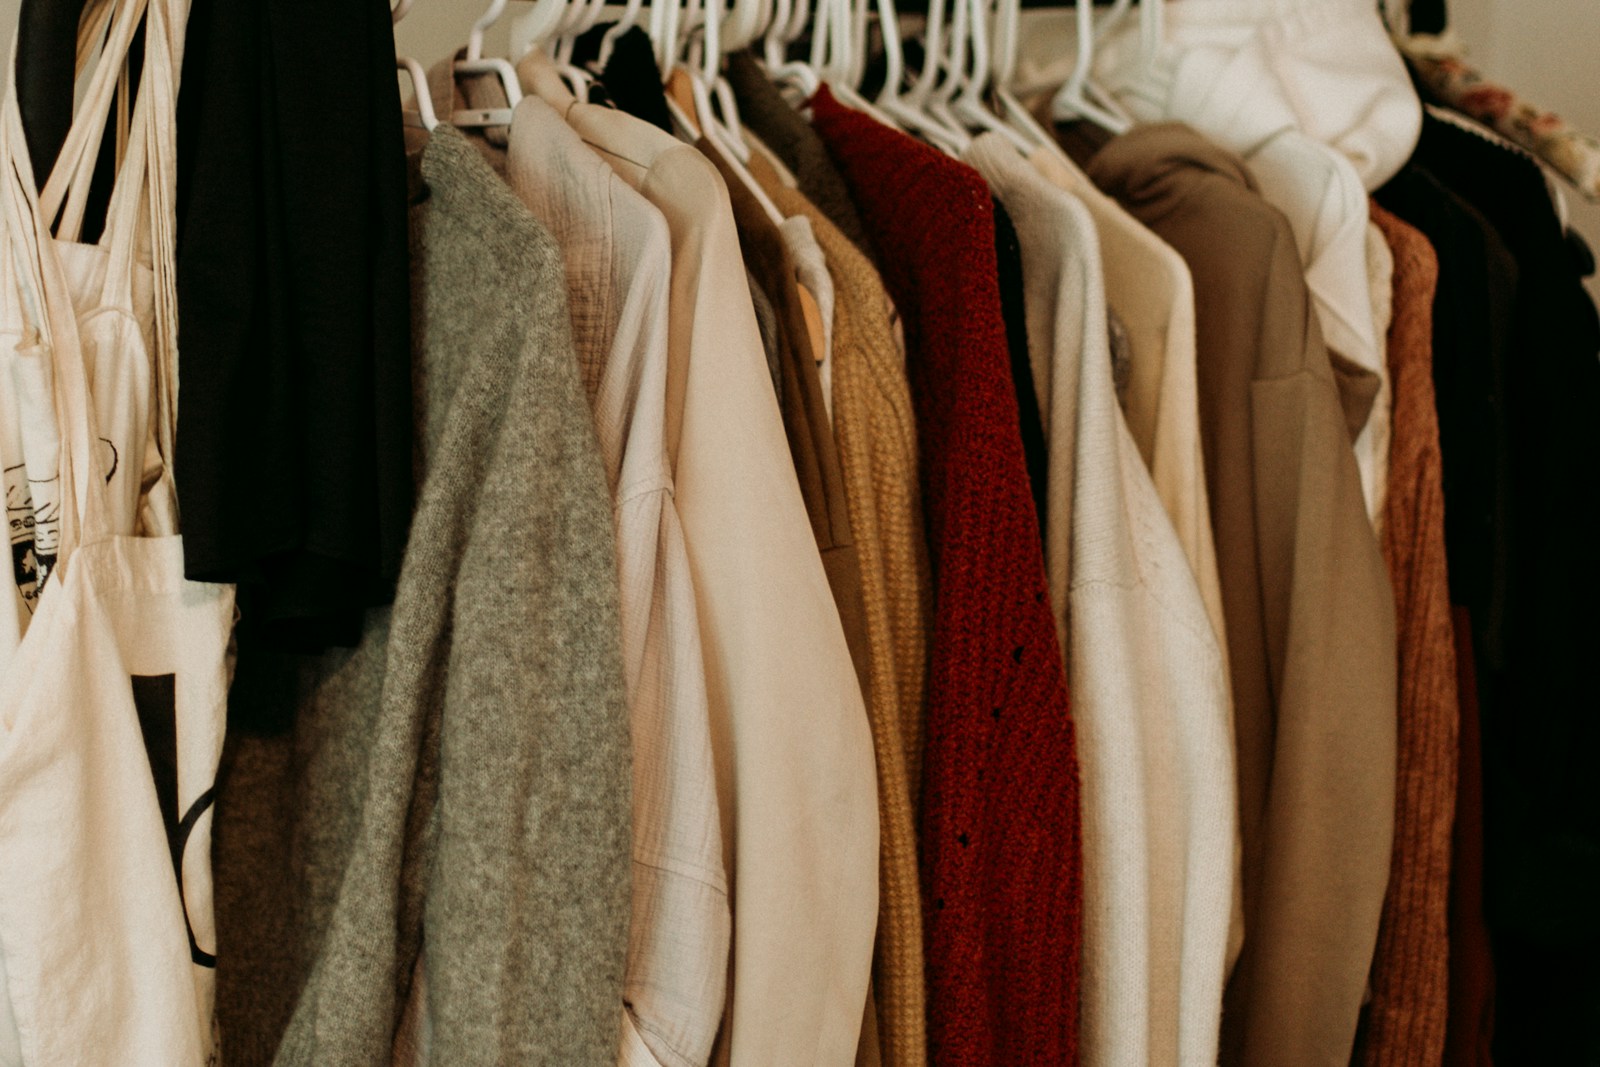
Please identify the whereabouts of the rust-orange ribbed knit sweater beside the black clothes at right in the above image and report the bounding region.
[1360,205,1461,1067]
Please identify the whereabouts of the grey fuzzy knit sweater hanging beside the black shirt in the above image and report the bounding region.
[216,126,632,1067]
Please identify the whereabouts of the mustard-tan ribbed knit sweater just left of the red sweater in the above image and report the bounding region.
[768,189,933,1067]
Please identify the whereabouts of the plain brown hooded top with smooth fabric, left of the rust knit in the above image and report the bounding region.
[1090,125,1397,1067]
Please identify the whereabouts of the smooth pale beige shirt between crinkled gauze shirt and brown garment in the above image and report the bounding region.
[518,53,878,1067]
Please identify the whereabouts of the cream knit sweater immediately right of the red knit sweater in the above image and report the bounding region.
[966,133,1237,1067]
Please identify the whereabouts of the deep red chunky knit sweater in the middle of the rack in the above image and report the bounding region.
[813,88,1083,1067]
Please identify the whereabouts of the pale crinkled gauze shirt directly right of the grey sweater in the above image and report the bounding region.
[506,96,733,1067]
